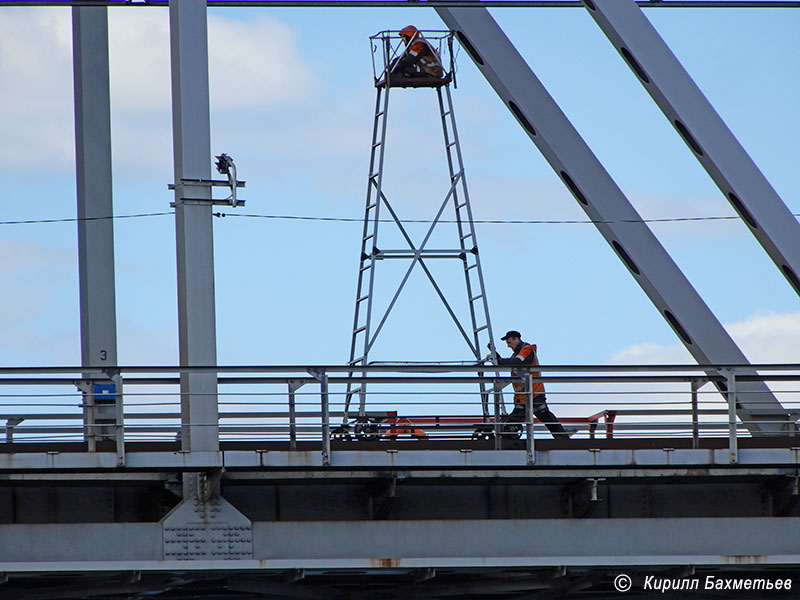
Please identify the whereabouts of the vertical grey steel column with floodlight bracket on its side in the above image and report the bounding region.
[169,0,219,451]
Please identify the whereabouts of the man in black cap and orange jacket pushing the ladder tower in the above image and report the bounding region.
[490,330,575,438]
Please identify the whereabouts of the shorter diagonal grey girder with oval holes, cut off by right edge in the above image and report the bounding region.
[584,0,800,294]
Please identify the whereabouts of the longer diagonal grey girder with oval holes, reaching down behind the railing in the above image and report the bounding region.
[436,7,788,435]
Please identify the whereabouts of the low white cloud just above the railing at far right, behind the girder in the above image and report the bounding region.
[608,312,800,364]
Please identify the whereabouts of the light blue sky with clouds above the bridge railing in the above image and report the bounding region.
[0,2,800,366]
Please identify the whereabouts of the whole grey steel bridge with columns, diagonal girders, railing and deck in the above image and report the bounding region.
[0,0,800,600]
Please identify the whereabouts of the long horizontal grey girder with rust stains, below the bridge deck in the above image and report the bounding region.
[0,517,800,573]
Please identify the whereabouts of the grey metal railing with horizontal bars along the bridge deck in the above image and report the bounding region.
[0,364,800,465]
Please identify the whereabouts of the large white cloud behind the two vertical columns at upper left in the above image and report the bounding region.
[0,8,316,171]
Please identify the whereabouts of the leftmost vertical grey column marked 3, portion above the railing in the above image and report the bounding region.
[72,7,117,367]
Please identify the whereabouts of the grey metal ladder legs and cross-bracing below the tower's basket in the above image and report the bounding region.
[344,82,494,425]
